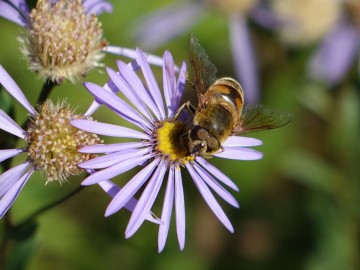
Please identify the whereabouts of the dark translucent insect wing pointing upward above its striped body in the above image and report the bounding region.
[189,34,217,97]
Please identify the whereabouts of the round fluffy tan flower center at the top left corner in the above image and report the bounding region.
[20,0,106,82]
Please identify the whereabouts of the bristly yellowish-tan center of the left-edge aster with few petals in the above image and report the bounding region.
[27,101,100,182]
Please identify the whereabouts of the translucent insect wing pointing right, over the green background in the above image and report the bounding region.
[234,104,292,134]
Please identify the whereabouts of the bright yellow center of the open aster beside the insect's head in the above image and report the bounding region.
[156,121,194,164]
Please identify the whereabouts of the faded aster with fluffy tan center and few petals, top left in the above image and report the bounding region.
[0,0,161,83]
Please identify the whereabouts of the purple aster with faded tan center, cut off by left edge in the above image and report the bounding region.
[0,65,159,223]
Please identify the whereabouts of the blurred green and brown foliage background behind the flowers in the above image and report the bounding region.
[0,0,360,270]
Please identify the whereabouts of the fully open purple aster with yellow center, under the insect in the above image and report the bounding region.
[72,49,262,252]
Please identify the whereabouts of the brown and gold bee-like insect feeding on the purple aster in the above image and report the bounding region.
[178,35,292,158]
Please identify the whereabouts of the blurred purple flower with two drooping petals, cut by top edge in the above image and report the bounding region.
[134,0,262,103]
